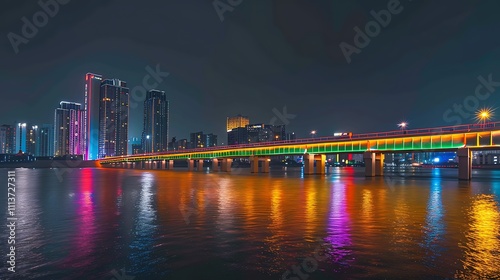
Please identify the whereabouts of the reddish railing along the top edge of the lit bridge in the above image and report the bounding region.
[107,122,500,159]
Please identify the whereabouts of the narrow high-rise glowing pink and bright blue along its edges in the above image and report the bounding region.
[83,73,102,160]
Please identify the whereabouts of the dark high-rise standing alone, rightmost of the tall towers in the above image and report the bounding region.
[142,89,169,153]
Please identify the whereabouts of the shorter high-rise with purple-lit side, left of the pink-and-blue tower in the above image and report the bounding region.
[54,101,84,156]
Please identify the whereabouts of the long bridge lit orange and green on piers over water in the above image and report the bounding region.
[99,122,500,180]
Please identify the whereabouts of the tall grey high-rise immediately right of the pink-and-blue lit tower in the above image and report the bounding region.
[98,79,129,158]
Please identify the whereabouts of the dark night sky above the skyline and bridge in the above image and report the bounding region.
[0,0,500,142]
